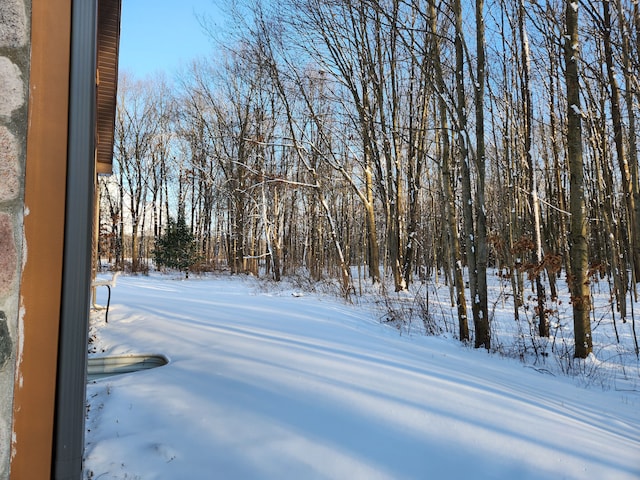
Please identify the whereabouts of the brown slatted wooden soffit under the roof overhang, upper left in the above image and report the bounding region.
[96,0,122,174]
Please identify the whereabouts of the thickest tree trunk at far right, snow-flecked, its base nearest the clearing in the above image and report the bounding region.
[564,0,593,358]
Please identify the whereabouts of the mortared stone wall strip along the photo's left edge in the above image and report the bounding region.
[0,0,30,480]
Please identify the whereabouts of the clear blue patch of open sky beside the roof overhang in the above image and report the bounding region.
[119,0,222,78]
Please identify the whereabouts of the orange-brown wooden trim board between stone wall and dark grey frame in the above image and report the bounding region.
[11,0,72,480]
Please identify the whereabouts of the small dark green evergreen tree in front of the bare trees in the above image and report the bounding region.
[154,215,198,278]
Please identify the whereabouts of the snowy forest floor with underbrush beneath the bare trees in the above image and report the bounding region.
[95,264,640,392]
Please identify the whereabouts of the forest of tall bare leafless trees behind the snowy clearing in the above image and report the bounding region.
[100,0,640,358]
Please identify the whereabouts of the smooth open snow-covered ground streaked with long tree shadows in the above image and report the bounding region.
[84,275,640,480]
